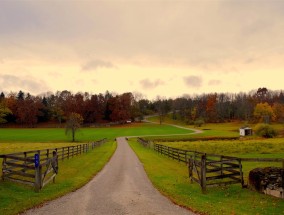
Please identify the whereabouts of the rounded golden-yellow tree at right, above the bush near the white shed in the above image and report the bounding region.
[253,102,275,123]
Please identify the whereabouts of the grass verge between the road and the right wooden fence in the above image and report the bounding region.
[130,140,284,215]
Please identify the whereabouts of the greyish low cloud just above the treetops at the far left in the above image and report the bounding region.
[0,75,50,95]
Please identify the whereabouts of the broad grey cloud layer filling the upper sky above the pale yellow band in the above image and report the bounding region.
[0,0,284,71]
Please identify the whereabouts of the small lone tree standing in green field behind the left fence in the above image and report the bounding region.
[65,112,83,142]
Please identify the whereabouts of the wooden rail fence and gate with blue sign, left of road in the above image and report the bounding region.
[0,139,106,192]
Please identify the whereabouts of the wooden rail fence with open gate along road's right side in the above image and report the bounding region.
[138,138,284,192]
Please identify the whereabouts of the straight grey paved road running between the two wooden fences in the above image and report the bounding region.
[25,138,193,215]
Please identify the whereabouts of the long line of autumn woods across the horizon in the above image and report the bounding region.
[0,88,284,127]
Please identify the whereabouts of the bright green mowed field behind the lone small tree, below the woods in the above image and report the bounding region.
[0,123,190,144]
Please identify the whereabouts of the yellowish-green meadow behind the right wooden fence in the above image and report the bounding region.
[157,138,284,182]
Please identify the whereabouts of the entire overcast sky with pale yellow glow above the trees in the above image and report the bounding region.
[0,0,284,99]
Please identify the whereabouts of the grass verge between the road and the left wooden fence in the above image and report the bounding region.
[0,141,116,215]
